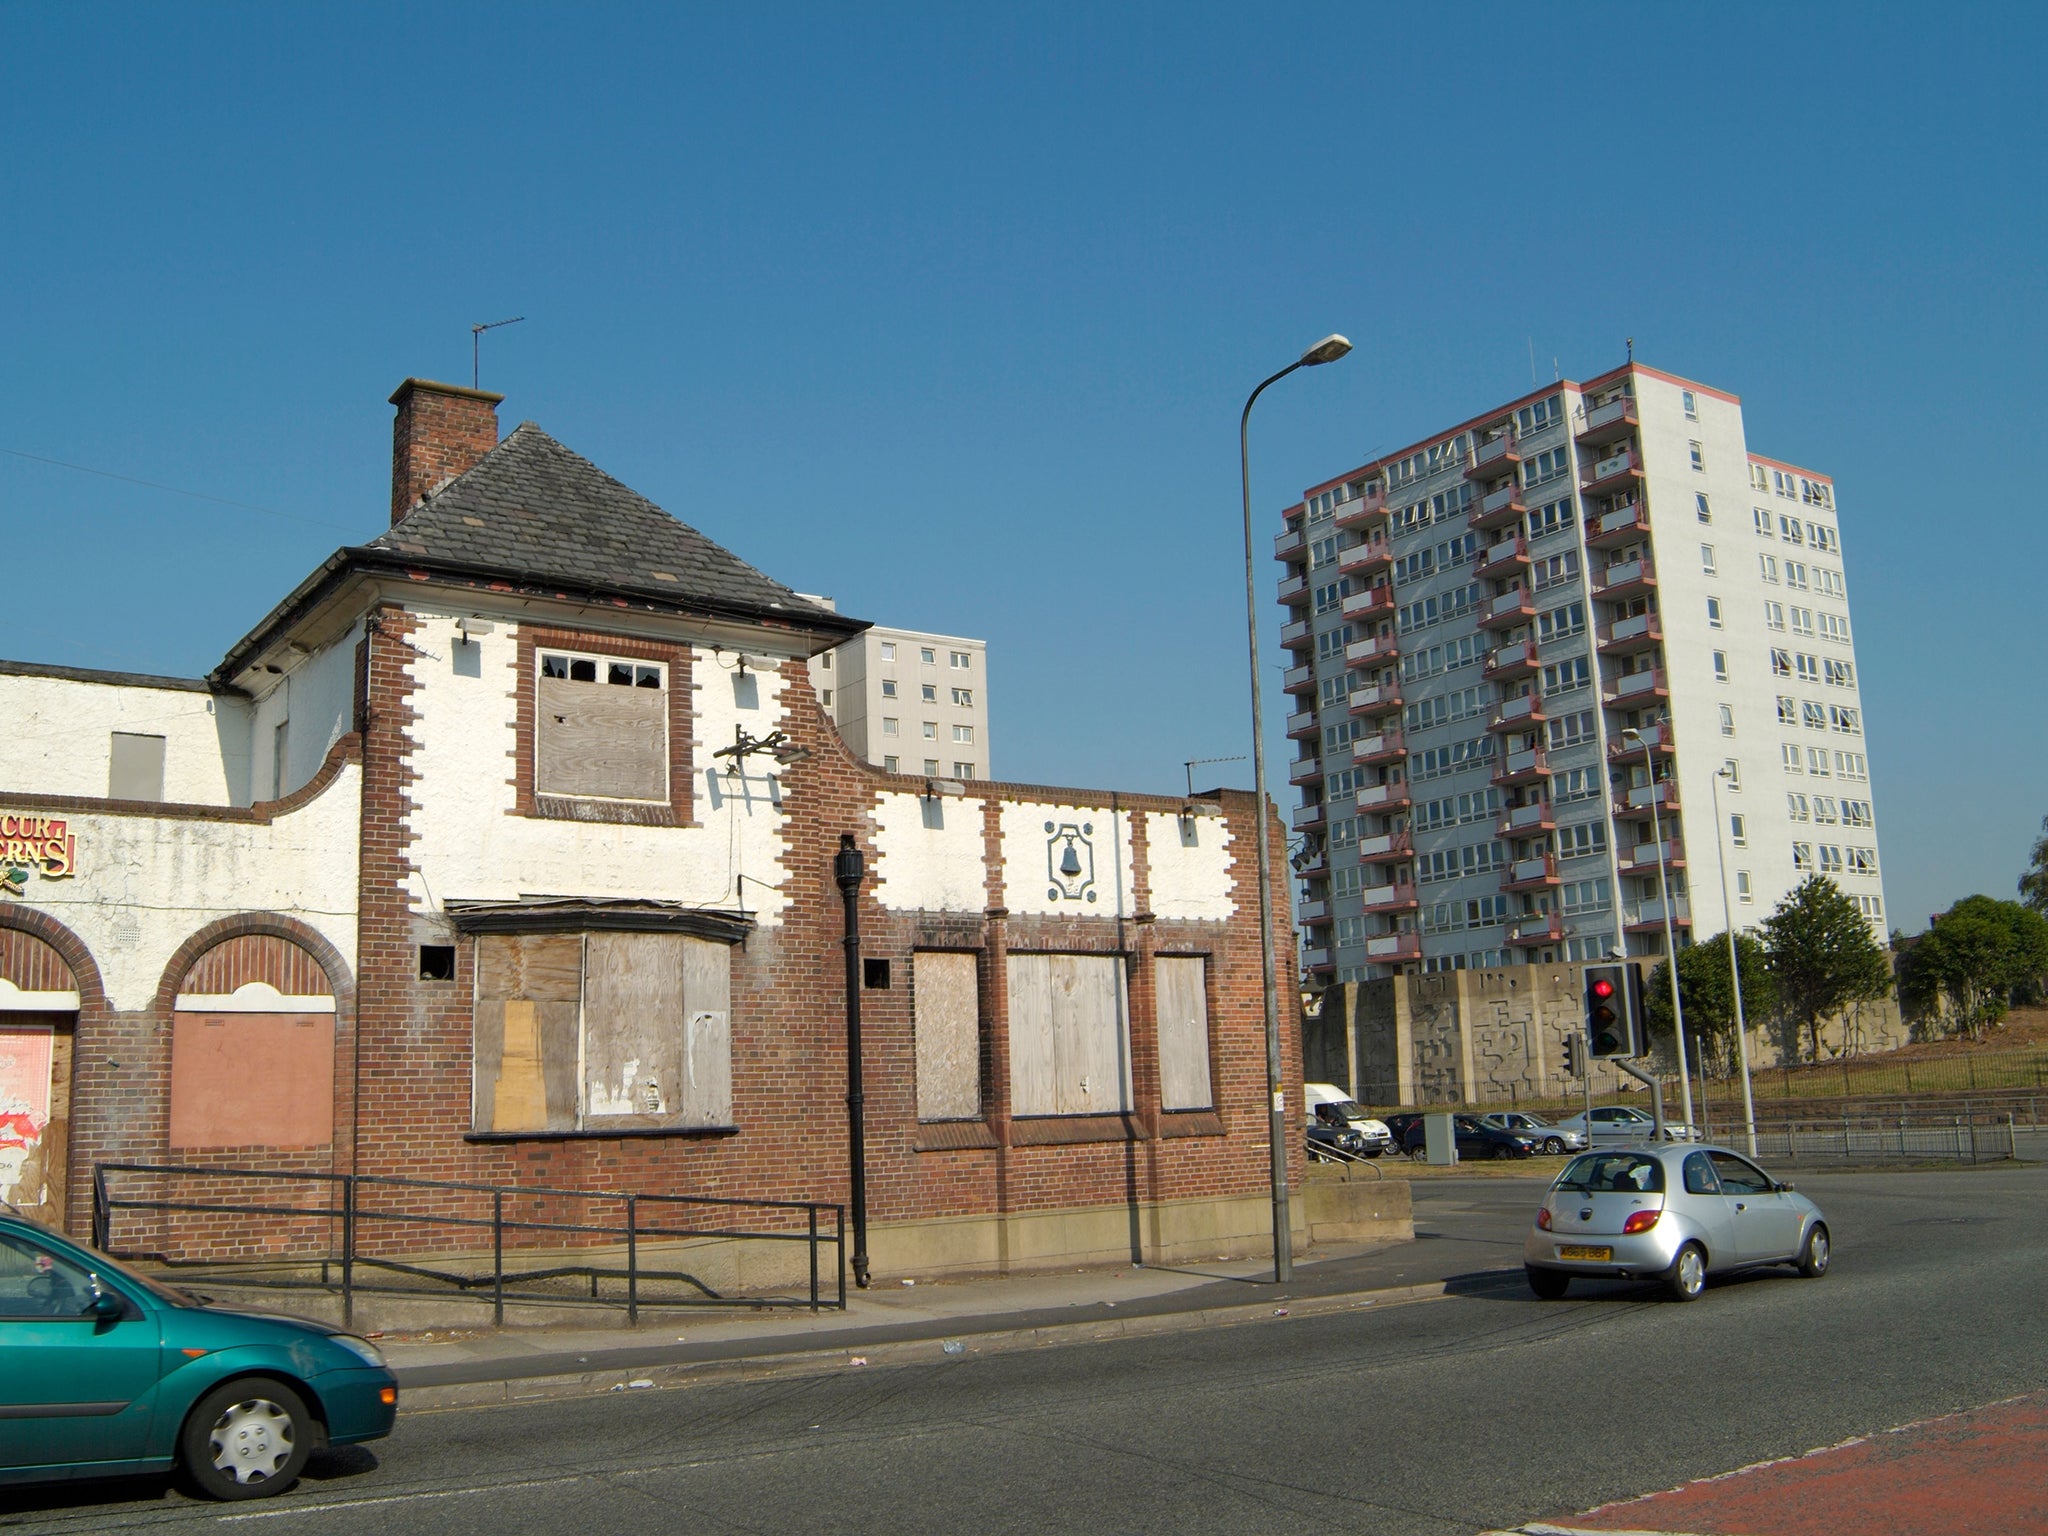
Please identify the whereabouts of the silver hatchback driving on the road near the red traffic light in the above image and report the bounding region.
[1522,1145,1831,1300]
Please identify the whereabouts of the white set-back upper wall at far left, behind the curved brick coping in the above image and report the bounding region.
[0,676,250,805]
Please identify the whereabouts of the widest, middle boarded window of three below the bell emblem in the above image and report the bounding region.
[1010,954,1130,1114]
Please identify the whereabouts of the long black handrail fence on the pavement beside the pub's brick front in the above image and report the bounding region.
[92,1163,846,1325]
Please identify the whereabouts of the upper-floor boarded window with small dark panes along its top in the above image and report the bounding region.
[532,651,668,801]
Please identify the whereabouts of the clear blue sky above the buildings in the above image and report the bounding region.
[0,4,2048,930]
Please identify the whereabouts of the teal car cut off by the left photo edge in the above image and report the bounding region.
[0,1206,397,1499]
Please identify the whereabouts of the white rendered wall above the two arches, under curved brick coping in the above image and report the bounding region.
[9,765,362,1010]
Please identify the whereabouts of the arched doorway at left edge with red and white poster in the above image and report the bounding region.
[0,928,78,1227]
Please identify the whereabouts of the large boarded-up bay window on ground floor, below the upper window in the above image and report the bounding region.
[475,934,733,1133]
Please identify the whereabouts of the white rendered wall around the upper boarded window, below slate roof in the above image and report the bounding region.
[406,608,788,928]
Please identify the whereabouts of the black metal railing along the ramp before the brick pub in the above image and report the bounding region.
[92,1163,846,1323]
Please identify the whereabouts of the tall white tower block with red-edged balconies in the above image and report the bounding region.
[1274,362,1884,981]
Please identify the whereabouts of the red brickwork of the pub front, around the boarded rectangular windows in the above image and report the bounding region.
[336,638,1300,1261]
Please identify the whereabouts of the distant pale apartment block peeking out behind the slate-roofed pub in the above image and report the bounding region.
[811,627,991,778]
